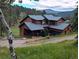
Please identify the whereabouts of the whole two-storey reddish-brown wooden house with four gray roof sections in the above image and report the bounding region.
[19,15,71,36]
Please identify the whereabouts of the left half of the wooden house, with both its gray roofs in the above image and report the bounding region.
[19,15,45,36]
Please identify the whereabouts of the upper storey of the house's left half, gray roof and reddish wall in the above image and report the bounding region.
[20,15,44,24]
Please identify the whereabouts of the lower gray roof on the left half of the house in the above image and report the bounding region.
[25,22,44,31]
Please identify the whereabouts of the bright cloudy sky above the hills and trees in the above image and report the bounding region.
[13,0,77,11]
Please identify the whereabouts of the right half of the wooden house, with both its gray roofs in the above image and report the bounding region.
[44,15,71,34]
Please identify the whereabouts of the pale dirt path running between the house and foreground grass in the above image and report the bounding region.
[0,35,76,47]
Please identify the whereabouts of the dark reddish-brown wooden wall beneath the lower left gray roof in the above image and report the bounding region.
[19,25,42,36]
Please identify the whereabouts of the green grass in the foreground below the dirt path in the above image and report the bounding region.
[0,41,78,59]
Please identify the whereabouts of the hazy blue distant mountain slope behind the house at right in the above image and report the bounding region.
[43,9,76,18]
